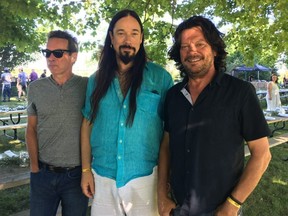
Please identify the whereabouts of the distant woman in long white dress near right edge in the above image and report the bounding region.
[266,74,281,111]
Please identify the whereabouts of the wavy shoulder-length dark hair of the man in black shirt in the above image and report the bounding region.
[168,16,227,79]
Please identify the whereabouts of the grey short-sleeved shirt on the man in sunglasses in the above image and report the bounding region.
[27,75,87,167]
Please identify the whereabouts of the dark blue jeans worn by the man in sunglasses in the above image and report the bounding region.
[30,167,88,216]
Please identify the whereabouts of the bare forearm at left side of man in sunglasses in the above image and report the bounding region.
[26,116,39,173]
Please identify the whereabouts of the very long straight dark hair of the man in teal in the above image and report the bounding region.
[90,9,147,126]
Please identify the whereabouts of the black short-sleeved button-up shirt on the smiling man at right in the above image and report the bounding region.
[165,74,270,215]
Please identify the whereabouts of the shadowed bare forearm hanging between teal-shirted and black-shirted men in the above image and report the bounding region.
[157,132,176,216]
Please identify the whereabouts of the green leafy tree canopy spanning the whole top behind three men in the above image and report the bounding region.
[0,0,288,67]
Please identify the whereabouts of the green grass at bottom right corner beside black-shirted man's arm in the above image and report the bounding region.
[243,143,288,216]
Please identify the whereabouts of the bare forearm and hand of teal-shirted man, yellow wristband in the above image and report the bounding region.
[81,118,95,198]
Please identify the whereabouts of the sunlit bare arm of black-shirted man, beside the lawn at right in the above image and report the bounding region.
[216,137,271,216]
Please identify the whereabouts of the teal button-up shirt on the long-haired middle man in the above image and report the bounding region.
[83,62,173,187]
